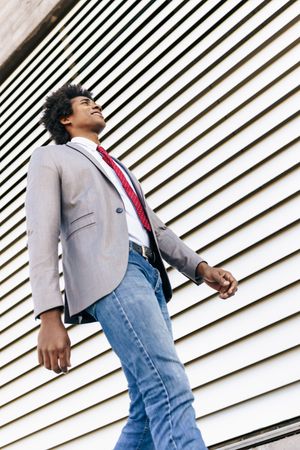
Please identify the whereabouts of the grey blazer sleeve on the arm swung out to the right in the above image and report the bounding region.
[145,199,207,285]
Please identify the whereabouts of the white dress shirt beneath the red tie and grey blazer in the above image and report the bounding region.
[71,137,150,247]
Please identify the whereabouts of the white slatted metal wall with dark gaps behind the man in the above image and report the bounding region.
[0,0,300,450]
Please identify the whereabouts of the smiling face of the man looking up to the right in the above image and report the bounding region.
[62,96,106,134]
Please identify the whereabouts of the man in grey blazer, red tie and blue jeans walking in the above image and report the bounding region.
[25,84,237,450]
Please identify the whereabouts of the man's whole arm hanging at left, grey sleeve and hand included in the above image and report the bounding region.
[25,147,71,373]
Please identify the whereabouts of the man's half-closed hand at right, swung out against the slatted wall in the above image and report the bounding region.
[196,262,238,299]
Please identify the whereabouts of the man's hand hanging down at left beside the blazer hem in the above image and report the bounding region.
[37,309,71,373]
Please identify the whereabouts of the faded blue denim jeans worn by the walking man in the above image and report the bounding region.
[86,241,207,450]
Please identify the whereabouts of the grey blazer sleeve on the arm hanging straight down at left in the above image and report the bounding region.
[25,147,64,320]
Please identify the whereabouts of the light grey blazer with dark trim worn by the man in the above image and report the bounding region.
[25,142,203,324]
